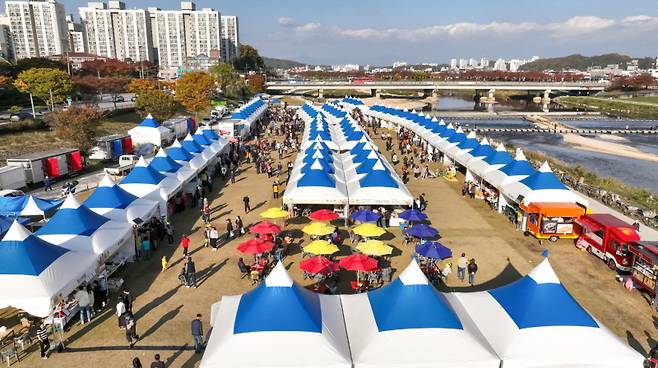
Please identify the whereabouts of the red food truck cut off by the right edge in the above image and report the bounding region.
[628,241,658,298]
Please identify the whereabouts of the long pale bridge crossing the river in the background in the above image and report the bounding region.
[266,81,606,101]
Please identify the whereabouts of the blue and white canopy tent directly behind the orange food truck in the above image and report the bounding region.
[501,162,589,208]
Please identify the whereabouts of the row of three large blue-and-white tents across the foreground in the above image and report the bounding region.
[201,258,643,368]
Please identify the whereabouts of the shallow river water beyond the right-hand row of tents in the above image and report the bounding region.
[426,96,658,193]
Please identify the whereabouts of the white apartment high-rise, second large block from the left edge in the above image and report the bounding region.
[80,1,154,61]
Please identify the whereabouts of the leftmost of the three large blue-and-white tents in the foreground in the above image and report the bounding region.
[201,263,352,368]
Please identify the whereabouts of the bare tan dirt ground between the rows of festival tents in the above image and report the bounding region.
[7,121,658,368]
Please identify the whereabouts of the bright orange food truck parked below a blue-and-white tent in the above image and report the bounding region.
[519,202,585,242]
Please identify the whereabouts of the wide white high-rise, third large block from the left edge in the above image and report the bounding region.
[154,1,222,68]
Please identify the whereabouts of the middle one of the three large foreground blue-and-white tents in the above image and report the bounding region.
[340,260,500,368]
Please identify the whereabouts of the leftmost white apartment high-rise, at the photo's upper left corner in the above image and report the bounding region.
[5,0,69,60]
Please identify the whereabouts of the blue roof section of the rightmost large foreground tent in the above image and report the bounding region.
[488,260,599,329]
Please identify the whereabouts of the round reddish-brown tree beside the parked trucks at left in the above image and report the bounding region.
[49,106,103,155]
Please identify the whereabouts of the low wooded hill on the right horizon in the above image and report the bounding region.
[520,54,654,71]
